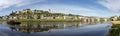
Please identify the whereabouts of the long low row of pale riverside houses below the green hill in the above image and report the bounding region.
[2,15,109,22]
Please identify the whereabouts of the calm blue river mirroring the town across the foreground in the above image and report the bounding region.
[0,22,112,36]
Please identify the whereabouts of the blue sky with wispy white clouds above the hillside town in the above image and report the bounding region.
[0,0,120,17]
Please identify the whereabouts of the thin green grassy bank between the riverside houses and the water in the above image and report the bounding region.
[0,19,80,22]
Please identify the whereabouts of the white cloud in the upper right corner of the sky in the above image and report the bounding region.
[98,0,120,12]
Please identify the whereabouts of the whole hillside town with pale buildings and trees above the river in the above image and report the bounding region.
[0,9,110,22]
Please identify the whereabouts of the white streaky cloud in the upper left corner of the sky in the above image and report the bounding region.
[0,0,45,9]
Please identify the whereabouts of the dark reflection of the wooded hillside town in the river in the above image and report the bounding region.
[10,22,81,33]
